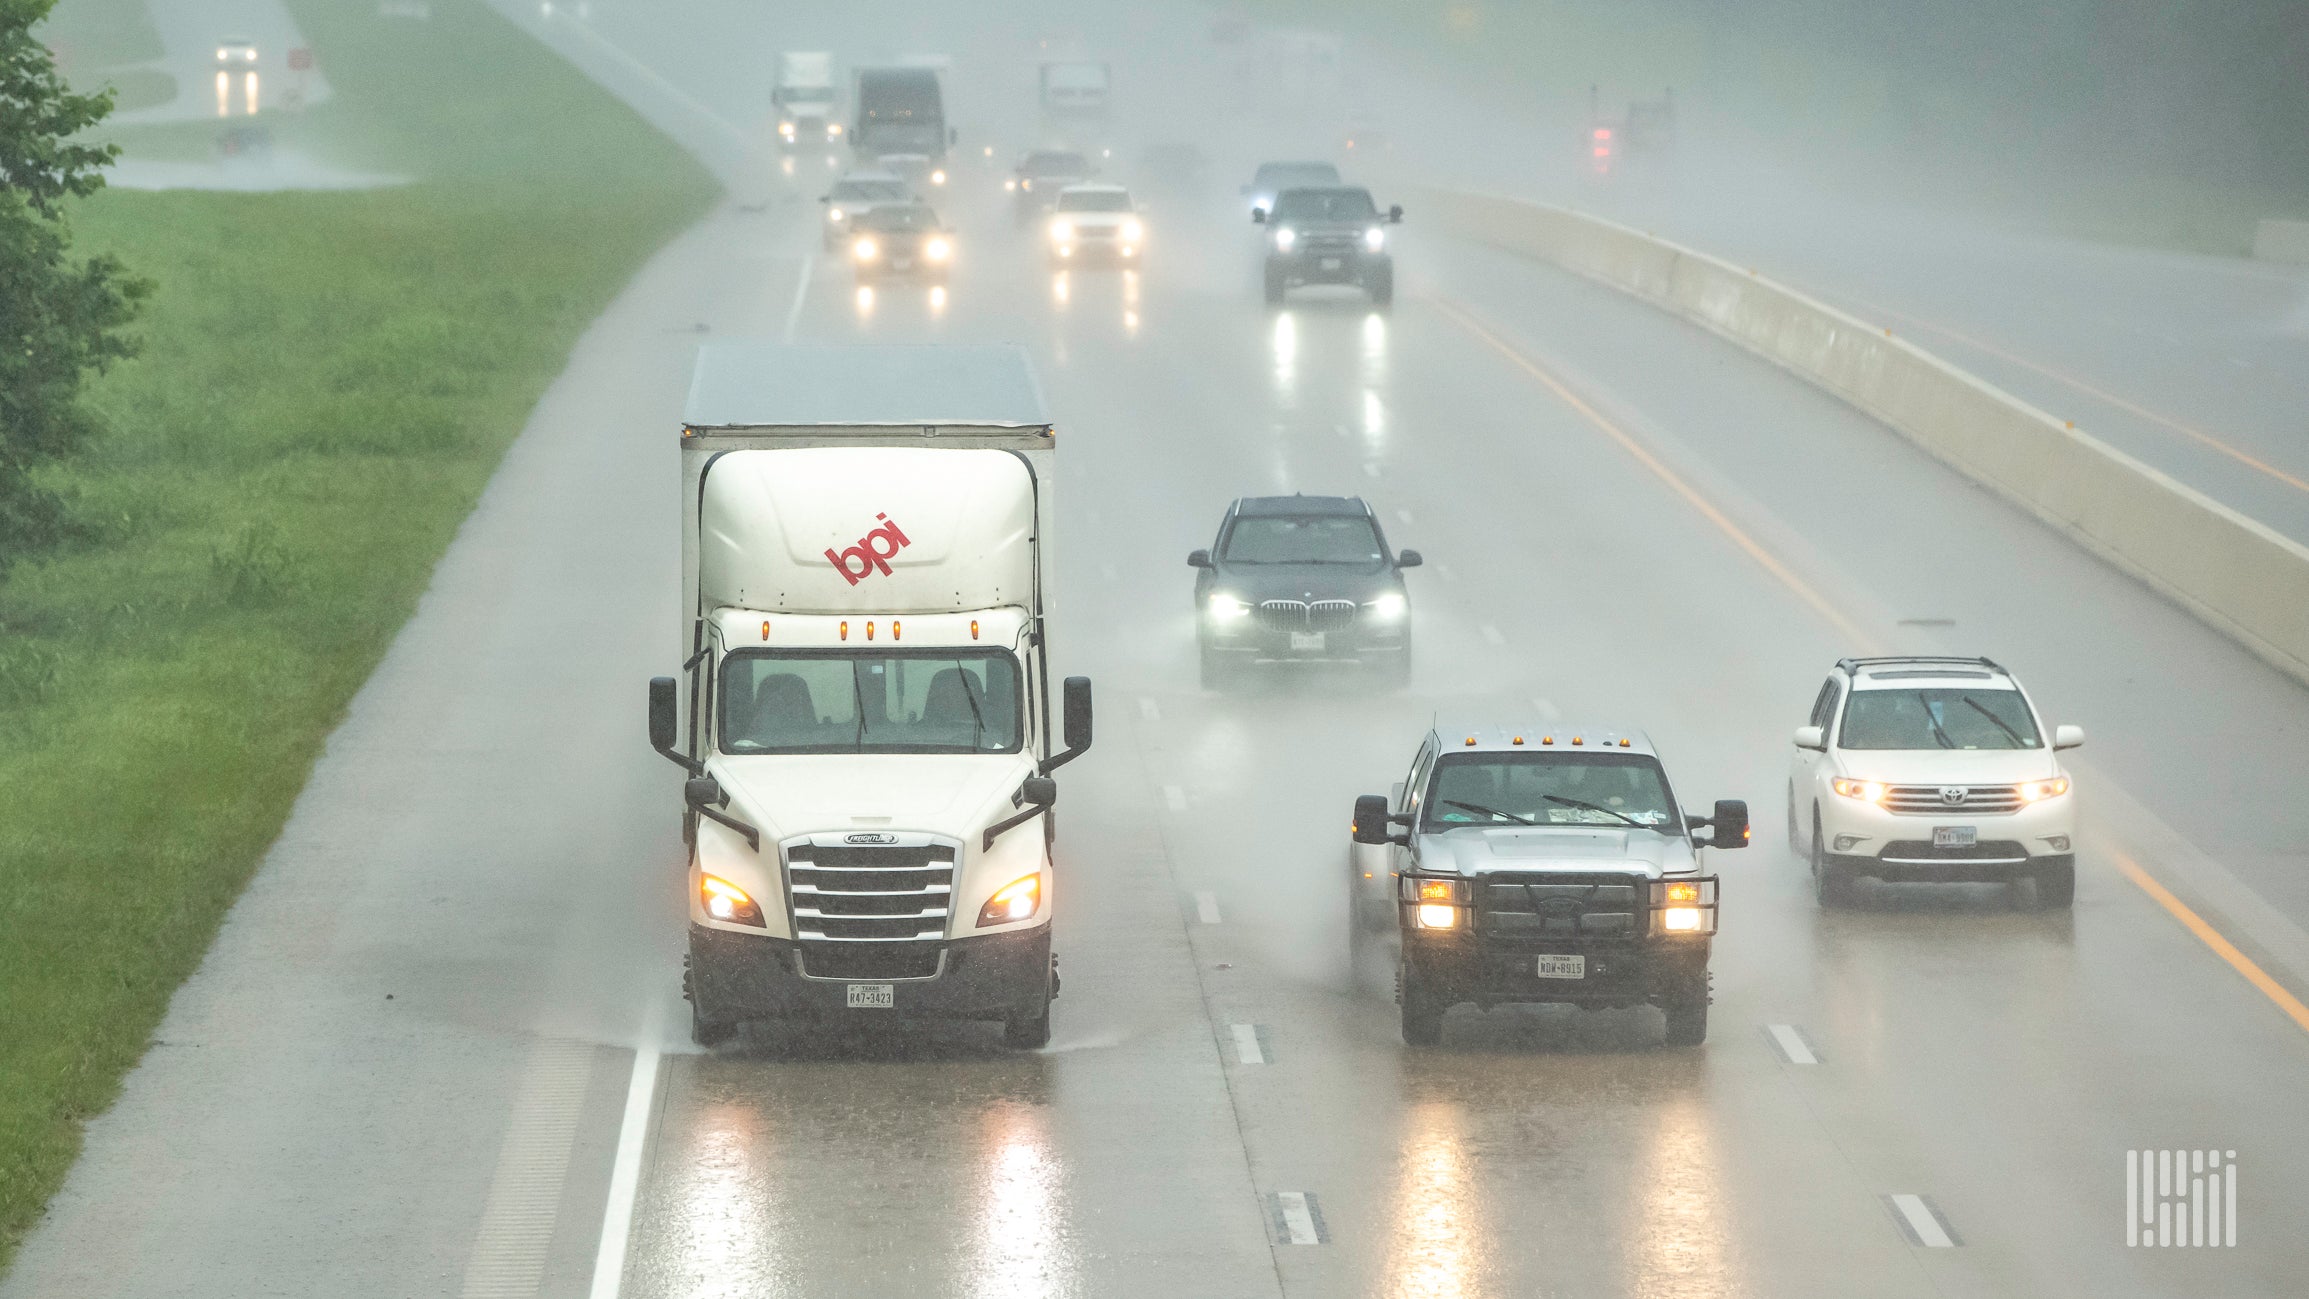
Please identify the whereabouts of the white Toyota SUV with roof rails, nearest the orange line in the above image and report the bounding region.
[1787,658,2085,907]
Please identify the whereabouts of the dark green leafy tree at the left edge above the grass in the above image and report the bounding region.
[0,0,150,570]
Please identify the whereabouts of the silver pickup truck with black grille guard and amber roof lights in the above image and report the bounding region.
[1348,720,1748,1045]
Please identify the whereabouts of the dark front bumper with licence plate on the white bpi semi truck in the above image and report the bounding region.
[690,925,1051,1022]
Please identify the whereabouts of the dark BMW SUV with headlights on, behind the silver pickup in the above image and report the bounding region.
[1187,496,1420,688]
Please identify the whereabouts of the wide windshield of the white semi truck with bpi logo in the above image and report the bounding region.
[718,648,1023,754]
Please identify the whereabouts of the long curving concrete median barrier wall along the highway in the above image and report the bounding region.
[1420,192,2309,683]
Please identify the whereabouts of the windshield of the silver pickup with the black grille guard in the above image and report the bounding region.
[1425,752,1683,835]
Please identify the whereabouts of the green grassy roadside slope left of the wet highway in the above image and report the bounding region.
[0,0,713,1264]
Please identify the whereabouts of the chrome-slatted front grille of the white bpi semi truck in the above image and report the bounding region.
[778,835,956,944]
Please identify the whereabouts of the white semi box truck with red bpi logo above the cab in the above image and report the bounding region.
[649,341,1090,1048]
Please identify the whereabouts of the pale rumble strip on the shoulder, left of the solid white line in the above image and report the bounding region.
[462,1038,593,1299]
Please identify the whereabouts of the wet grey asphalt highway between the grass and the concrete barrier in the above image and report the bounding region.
[0,7,2309,1299]
